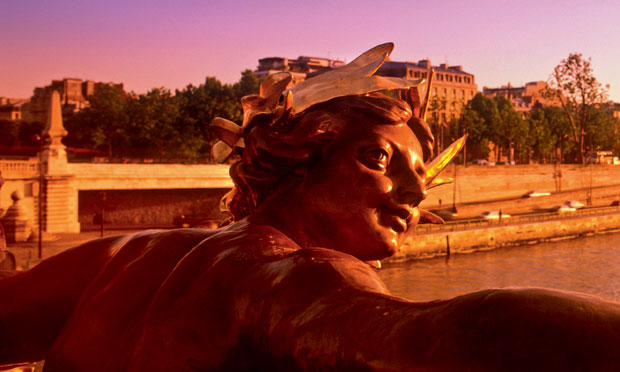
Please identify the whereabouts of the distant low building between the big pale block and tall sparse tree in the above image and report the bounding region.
[482,81,555,112]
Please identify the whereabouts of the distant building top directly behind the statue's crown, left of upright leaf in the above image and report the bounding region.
[254,56,345,84]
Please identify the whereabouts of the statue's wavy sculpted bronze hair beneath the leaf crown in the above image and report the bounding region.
[222,93,433,221]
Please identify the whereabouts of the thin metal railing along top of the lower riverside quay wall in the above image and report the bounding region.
[416,206,620,234]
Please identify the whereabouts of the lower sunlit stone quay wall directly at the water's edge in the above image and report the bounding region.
[388,213,620,262]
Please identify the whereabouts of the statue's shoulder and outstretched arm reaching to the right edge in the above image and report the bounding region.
[246,250,620,371]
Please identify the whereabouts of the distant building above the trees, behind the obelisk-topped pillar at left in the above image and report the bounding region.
[24,78,123,122]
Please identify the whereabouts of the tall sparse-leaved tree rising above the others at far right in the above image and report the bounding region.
[543,53,607,164]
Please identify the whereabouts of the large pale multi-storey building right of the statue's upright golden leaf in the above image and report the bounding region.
[376,59,478,125]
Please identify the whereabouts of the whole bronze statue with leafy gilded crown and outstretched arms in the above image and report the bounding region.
[0,44,620,372]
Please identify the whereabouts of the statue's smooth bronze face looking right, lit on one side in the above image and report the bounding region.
[302,123,426,260]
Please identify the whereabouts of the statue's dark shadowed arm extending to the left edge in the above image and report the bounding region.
[0,237,124,366]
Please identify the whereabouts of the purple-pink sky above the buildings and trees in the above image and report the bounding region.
[0,0,620,102]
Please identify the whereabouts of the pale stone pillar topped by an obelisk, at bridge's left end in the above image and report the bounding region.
[39,91,80,233]
